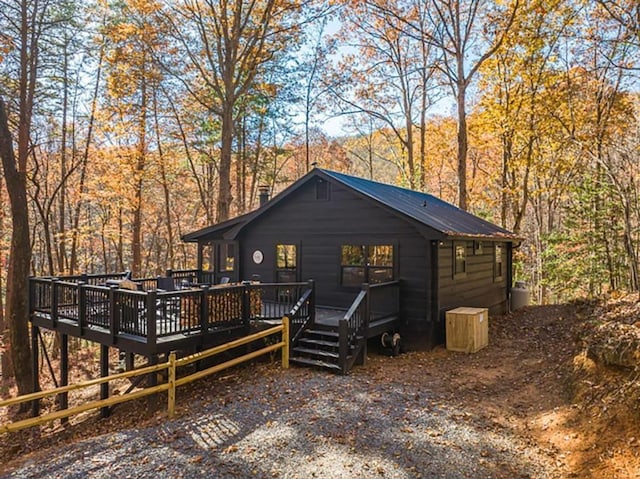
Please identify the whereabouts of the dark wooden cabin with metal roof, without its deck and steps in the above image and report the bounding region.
[183,168,518,359]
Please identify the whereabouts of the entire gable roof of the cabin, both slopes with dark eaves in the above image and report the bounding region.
[182,168,520,241]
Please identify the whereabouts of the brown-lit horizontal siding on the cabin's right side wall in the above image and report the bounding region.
[438,241,508,319]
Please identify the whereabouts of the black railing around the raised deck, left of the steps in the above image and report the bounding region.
[29,271,315,354]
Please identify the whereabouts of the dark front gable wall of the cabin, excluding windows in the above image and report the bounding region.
[238,181,431,342]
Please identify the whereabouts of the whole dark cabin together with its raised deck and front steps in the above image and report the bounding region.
[29,168,519,386]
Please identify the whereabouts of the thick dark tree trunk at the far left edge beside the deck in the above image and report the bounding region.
[0,98,33,398]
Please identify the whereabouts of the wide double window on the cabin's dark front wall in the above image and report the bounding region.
[340,245,393,287]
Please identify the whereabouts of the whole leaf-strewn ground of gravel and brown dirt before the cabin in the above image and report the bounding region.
[0,306,640,479]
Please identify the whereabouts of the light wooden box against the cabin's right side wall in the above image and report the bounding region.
[446,308,489,353]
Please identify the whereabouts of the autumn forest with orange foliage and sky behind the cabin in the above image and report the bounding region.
[0,0,640,391]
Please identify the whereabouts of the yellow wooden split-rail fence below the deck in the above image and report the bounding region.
[0,316,289,434]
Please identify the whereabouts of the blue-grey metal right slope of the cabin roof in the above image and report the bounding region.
[319,169,518,239]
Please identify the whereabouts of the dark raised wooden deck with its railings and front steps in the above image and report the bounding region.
[29,271,400,374]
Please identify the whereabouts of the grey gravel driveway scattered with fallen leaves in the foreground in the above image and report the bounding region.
[1,357,562,479]
